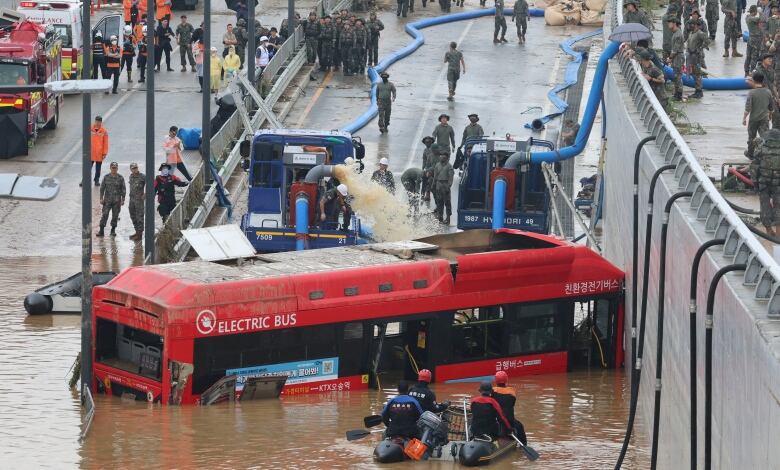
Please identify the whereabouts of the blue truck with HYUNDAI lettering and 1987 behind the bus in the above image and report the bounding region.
[458,137,553,233]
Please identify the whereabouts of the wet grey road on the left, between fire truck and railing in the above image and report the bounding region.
[0,0,314,264]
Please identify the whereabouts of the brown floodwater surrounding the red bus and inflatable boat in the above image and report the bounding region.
[0,257,648,469]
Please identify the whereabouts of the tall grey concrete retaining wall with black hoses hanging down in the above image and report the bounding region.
[602,61,780,469]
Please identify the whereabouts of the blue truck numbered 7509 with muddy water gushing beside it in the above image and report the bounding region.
[241,129,363,253]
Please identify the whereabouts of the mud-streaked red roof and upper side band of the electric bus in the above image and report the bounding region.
[93,229,624,336]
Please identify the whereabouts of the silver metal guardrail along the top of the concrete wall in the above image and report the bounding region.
[605,0,780,316]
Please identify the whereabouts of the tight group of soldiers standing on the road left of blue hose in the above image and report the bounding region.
[303,10,385,76]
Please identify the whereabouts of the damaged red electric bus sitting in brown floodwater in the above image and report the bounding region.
[92,229,624,404]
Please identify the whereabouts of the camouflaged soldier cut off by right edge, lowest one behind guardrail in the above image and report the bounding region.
[754,129,780,236]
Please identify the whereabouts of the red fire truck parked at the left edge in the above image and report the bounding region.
[0,16,63,158]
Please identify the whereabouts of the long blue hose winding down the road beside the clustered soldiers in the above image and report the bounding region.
[342,8,544,134]
